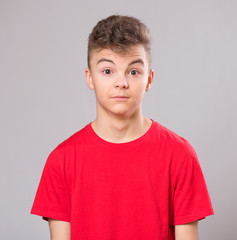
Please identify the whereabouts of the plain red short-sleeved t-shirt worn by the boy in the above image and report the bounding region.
[31,119,214,240]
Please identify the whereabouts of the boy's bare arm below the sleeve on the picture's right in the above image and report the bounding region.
[175,221,198,240]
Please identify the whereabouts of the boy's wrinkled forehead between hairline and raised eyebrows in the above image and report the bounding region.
[91,45,148,65]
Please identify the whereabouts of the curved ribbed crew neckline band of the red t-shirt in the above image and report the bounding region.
[87,118,155,148]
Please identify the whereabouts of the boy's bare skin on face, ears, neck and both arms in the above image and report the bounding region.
[49,45,198,240]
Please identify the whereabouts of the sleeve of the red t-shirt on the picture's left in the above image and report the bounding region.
[31,148,70,222]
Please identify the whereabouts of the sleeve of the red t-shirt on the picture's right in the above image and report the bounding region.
[173,141,214,225]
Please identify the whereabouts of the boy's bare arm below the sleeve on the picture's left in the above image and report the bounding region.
[48,218,71,240]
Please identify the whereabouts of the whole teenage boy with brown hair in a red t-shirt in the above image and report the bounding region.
[31,15,214,240]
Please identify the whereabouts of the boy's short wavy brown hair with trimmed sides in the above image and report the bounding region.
[87,15,151,69]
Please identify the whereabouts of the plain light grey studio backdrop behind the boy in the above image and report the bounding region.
[0,0,237,240]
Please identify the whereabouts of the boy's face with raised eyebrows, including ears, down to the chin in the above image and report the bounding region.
[85,45,154,117]
